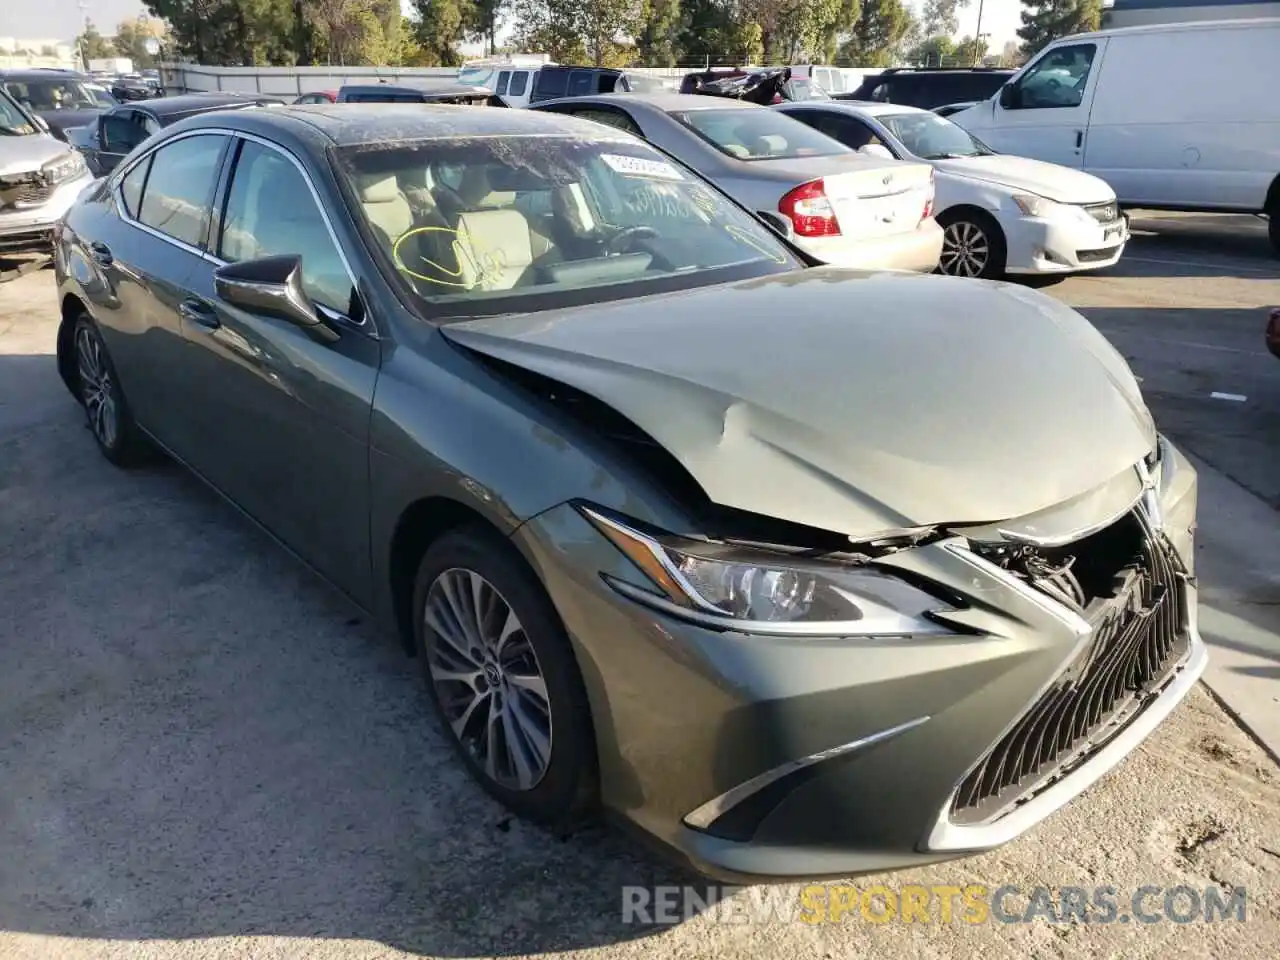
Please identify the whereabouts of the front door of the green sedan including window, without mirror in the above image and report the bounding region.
[183,140,380,602]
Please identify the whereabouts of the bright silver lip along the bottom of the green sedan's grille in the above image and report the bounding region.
[922,622,1208,854]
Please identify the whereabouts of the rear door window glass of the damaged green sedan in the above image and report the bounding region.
[138,133,227,247]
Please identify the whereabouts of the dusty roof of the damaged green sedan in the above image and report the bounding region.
[174,104,621,146]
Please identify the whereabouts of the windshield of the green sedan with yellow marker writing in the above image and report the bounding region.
[338,133,797,317]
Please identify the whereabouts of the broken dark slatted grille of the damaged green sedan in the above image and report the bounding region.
[951,513,1189,823]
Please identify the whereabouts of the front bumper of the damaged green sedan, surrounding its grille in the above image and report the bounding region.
[515,448,1206,882]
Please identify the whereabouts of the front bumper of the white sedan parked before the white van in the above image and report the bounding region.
[1001,208,1129,274]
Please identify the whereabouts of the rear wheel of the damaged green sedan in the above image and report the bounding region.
[72,314,152,467]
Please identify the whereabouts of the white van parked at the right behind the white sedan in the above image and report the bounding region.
[951,18,1280,253]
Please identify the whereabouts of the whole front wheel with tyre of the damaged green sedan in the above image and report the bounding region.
[413,526,596,827]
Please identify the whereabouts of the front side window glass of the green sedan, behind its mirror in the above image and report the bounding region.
[218,141,352,314]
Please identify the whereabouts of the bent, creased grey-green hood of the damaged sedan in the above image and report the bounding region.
[443,269,1156,539]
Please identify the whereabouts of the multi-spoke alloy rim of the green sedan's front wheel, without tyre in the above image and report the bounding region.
[424,567,552,791]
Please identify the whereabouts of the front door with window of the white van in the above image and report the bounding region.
[961,40,1107,168]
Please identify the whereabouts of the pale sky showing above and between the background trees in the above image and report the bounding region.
[0,0,1020,51]
